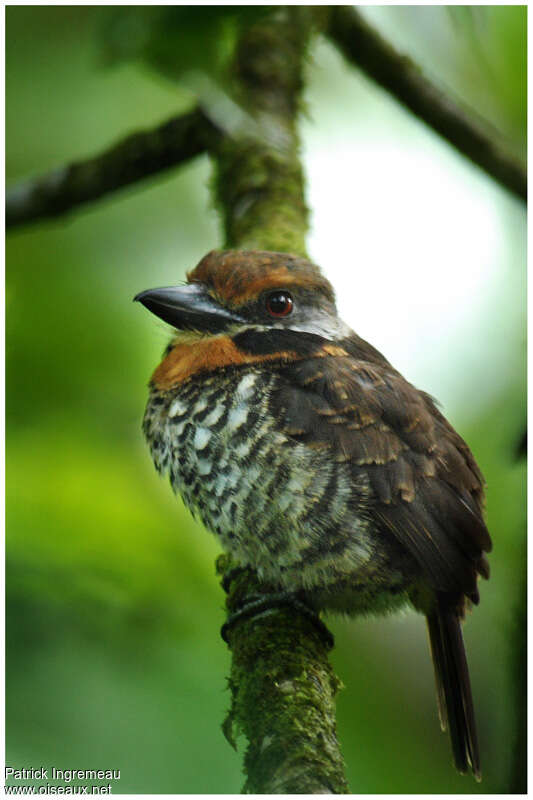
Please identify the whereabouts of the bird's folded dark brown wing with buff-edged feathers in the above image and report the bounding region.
[272,340,491,602]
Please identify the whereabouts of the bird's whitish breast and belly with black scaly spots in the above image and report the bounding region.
[144,365,372,586]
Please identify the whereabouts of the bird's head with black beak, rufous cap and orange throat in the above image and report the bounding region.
[135,250,350,388]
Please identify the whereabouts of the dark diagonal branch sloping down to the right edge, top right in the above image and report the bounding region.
[327,6,527,201]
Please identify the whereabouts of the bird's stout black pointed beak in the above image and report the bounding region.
[133,283,245,333]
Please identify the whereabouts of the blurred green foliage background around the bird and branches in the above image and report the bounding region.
[6,6,525,793]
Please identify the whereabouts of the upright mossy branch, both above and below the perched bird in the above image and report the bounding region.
[210,7,348,794]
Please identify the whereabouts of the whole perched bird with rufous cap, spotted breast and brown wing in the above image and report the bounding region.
[134,250,492,780]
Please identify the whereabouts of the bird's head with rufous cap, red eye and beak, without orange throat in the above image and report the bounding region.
[135,250,344,340]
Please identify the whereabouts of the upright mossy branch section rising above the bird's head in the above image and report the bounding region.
[214,6,314,255]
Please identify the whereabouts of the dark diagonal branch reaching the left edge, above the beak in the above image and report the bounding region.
[6,108,220,228]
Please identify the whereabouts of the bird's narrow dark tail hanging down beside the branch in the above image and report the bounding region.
[427,598,481,780]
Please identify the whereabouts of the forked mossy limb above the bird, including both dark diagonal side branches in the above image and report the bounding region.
[6,6,527,231]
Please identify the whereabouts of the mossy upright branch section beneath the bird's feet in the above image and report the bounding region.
[217,556,348,794]
